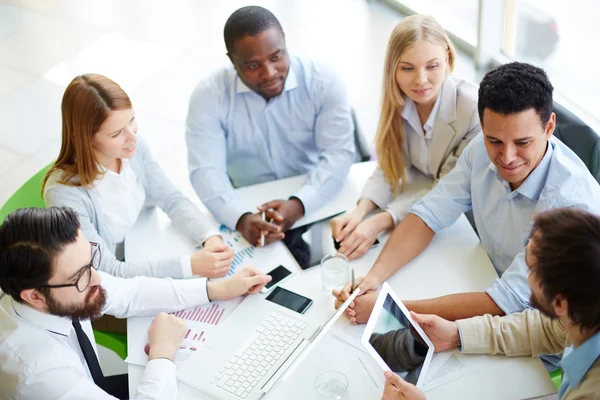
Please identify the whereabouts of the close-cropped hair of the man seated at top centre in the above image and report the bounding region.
[223,6,283,53]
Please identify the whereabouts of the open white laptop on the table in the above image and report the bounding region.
[177,290,359,400]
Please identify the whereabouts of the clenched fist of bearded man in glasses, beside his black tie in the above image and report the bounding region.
[148,312,187,361]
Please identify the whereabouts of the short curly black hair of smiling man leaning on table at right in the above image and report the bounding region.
[477,62,554,127]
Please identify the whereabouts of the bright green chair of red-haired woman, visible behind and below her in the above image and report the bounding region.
[0,164,127,360]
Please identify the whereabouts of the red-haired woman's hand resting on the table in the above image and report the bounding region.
[190,241,235,278]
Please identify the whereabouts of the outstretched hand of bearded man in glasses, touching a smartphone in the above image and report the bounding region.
[207,266,272,300]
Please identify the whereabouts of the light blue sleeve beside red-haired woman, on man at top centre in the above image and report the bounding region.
[186,77,252,229]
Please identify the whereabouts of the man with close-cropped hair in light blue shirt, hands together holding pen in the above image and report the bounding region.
[186,6,354,253]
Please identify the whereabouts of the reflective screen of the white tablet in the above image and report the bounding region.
[365,293,433,385]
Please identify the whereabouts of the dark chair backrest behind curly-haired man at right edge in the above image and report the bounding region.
[554,102,600,183]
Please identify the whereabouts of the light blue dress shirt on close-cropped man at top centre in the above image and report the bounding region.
[186,57,354,229]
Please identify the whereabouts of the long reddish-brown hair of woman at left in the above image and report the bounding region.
[42,74,132,191]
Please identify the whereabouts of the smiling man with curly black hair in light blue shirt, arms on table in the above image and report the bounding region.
[336,63,600,322]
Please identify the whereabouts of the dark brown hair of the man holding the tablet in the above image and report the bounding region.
[532,208,600,330]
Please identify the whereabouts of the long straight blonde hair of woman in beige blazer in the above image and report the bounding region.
[375,15,456,197]
